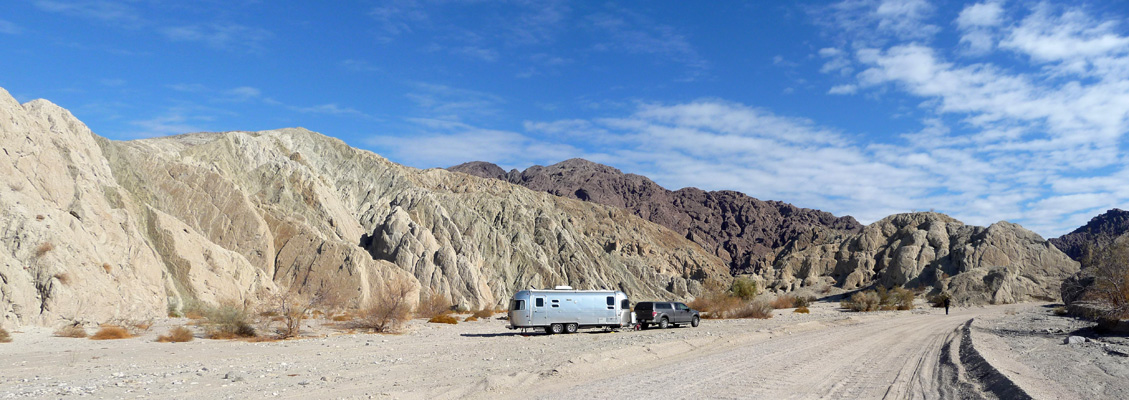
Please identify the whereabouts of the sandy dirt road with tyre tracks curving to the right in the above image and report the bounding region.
[528,307,999,399]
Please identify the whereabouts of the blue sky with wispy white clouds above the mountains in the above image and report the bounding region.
[0,0,1129,236]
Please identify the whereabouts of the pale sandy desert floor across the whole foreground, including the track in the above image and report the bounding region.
[0,303,1129,399]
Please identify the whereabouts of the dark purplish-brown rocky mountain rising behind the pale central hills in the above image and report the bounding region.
[448,158,861,273]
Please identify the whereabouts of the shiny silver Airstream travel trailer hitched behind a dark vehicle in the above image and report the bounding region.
[506,286,632,333]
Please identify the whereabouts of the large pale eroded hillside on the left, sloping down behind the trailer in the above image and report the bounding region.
[0,89,730,324]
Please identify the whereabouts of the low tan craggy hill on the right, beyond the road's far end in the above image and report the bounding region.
[764,212,1078,304]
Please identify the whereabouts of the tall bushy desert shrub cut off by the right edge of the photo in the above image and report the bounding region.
[1080,238,1129,319]
